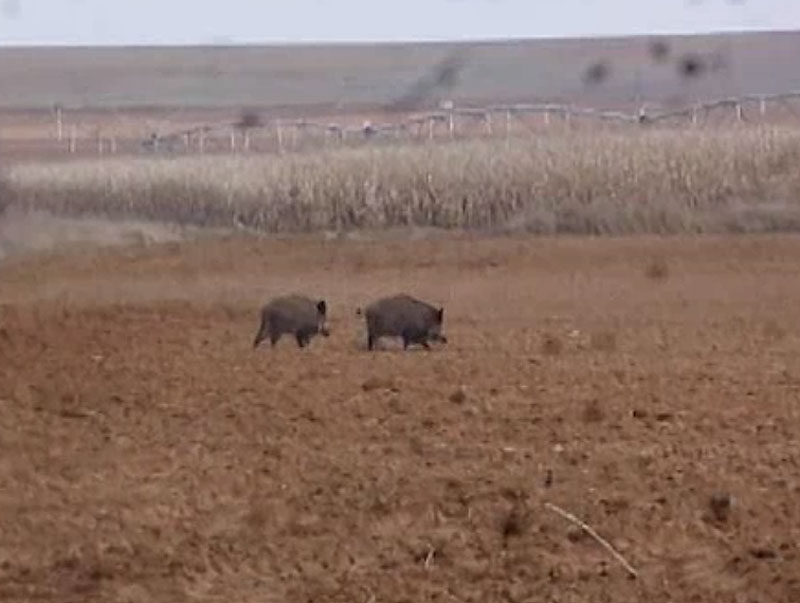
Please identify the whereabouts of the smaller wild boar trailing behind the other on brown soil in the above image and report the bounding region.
[253,295,330,349]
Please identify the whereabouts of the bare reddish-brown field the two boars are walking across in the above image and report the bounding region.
[0,232,800,603]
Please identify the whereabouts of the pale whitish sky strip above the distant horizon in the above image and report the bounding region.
[0,0,800,45]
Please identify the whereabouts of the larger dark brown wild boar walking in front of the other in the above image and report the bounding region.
[357,294,447,350]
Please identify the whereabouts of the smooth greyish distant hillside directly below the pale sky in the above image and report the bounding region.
[0,32,800,111]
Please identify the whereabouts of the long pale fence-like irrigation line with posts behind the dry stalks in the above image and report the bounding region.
[18,91,800,155]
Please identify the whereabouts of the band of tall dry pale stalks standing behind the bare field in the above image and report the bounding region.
[9,128,800,234]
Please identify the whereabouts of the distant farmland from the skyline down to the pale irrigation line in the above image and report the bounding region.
[0,32,800,161]
